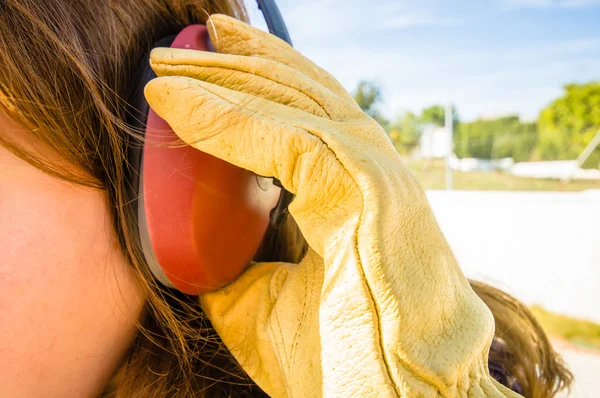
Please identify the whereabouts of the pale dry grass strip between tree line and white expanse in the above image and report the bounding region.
[403,158,600,191]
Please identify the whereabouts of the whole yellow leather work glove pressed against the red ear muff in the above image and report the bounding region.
[145,15,518,398]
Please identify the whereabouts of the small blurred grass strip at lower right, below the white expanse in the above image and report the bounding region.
[531,306,600,350]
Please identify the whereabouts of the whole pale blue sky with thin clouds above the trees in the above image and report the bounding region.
[246,0,600,120]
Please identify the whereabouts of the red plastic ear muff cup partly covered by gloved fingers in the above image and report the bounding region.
[132,25,281,295]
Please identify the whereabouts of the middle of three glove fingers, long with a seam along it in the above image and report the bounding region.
[150,48,362,120]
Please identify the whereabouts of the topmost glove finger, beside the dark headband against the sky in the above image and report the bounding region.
[206,14,355,104]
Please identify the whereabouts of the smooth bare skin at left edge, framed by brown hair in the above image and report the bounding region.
[0,115,144,397]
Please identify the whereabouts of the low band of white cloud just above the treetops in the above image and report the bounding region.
[305,37,600,120]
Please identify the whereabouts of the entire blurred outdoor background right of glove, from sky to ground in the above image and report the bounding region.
[246,0,600,397]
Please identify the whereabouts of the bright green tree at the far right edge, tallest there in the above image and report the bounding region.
[536,82,600,168]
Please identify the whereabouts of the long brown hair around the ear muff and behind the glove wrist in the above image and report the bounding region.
[0,0,572,397]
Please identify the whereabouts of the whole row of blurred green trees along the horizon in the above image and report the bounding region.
[354,81,600,168]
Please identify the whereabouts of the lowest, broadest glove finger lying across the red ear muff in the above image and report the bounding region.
[145,76,354,194]
